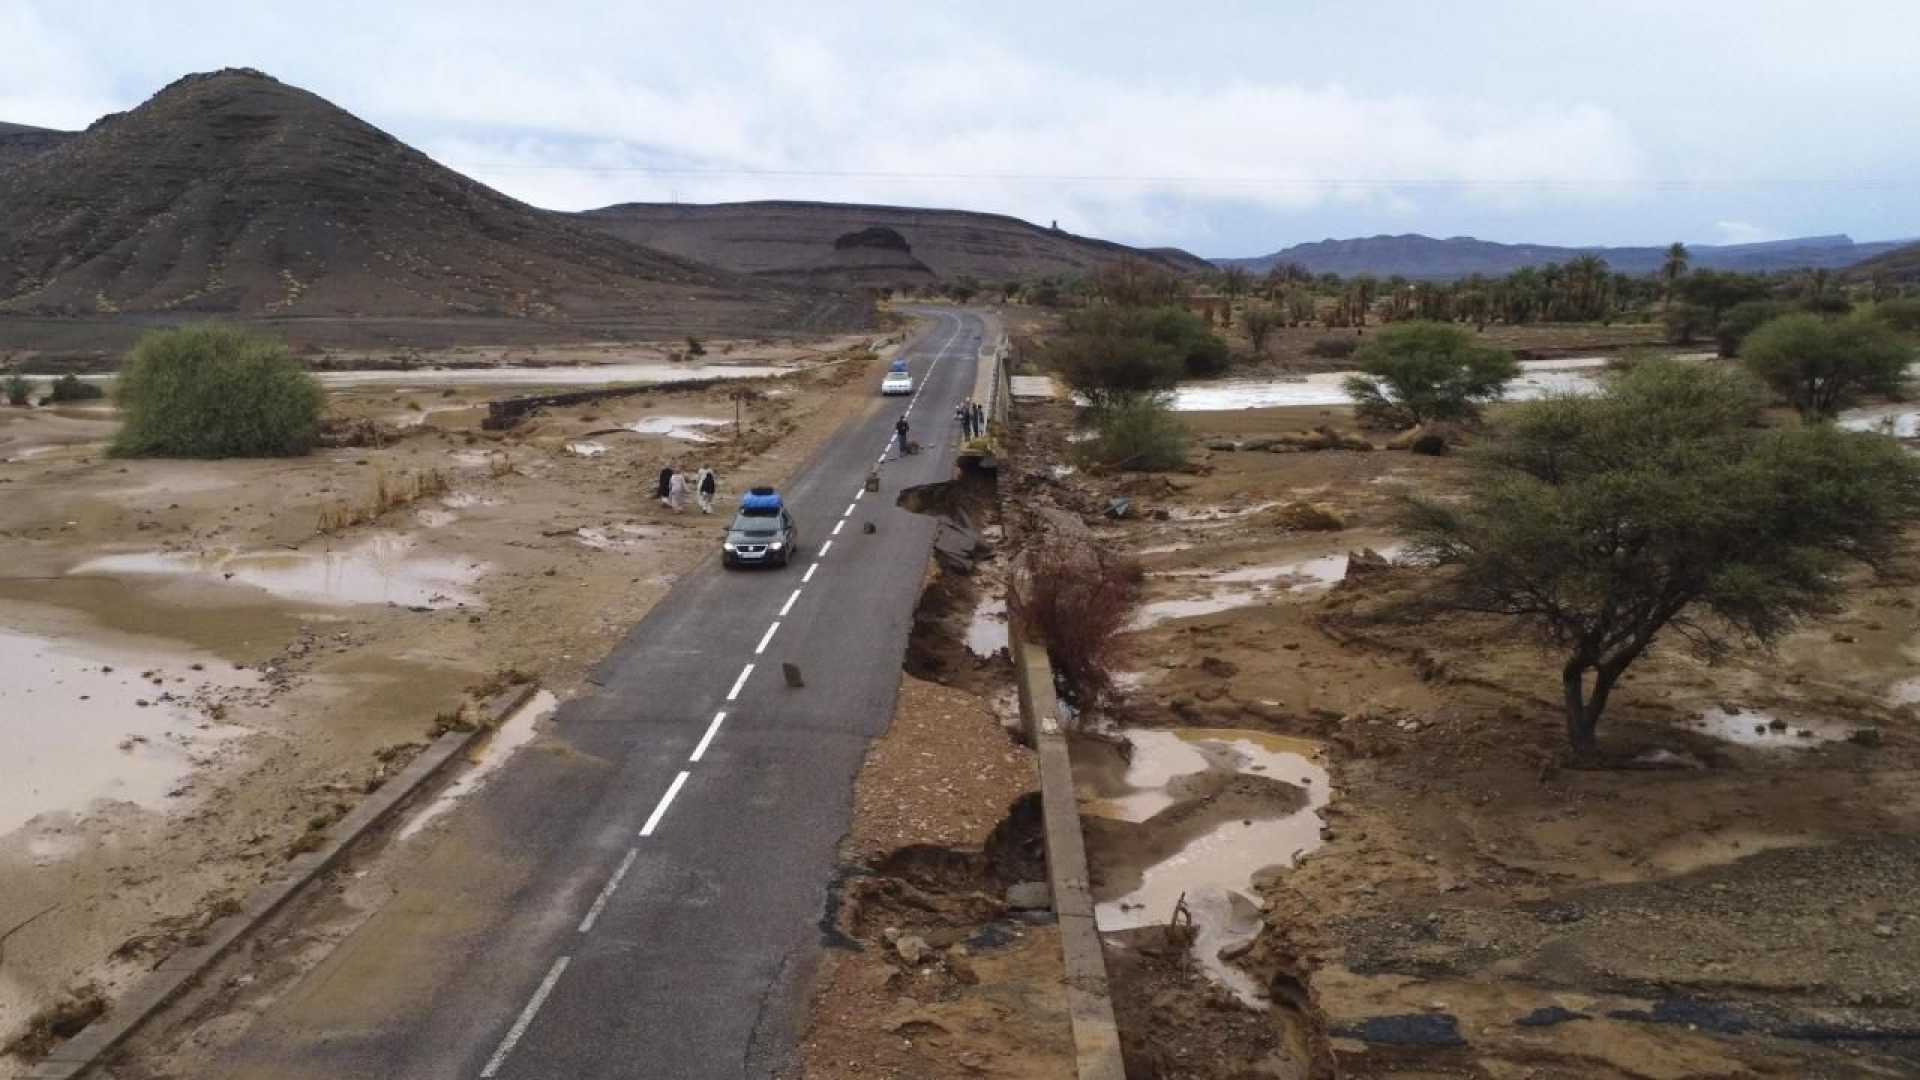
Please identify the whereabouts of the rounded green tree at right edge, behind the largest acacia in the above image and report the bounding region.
[1740,315,1912,417]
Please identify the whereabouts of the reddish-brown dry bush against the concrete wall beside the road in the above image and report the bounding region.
[1008,538,1142,709]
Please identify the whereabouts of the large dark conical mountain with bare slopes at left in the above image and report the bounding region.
[0,69,854,329]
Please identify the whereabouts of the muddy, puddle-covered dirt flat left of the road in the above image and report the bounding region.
[0,336,885,1049]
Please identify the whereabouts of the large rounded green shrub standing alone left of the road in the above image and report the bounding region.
[113,323,324,457]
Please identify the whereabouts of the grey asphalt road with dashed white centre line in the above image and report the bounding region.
[217,311,985,1080]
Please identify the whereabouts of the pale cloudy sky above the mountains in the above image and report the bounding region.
[0,0,1920,256]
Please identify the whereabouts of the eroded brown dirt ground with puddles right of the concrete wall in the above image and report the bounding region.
[1002,393,1920,1078]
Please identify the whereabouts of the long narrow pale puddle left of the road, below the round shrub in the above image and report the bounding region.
[69,534,484,607]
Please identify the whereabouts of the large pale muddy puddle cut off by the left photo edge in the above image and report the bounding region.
[0,628,259,834]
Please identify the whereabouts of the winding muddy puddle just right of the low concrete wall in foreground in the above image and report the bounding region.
[1089,728,1332,1007]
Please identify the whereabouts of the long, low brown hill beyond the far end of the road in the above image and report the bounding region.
[576,202,1212,286]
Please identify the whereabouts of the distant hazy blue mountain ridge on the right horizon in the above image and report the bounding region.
[1213,233,1908,281]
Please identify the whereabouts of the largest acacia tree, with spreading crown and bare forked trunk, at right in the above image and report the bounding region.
[1402,359,1920,753]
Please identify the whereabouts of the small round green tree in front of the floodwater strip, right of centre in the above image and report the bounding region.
[1342,323,1521,429]
